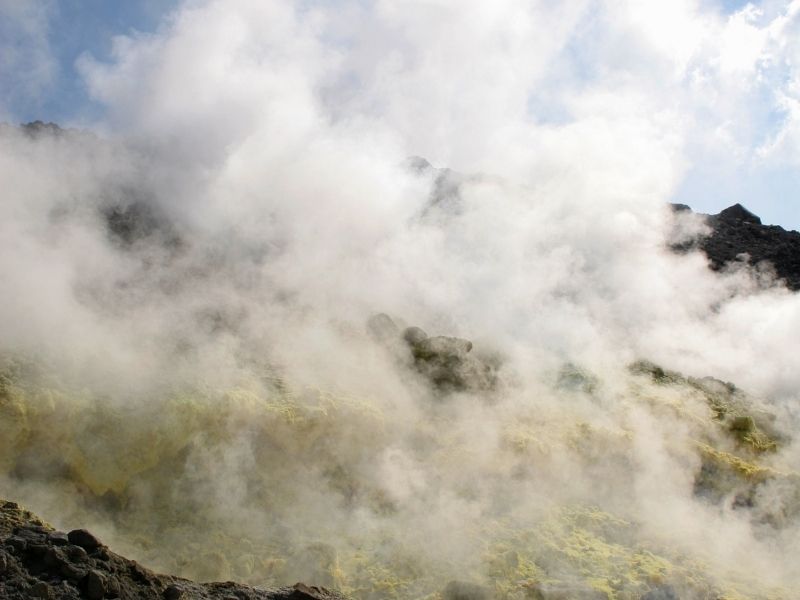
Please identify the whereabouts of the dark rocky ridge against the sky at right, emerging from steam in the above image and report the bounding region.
[672,204,800,291]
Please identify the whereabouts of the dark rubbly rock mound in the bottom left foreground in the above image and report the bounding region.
[0,500,343,600]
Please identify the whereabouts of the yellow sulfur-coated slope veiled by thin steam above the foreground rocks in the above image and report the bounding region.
[0,358,796,600]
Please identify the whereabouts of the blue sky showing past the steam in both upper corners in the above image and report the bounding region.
[0,0,800,229]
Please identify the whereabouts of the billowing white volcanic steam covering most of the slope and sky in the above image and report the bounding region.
[0,0,800,597]
